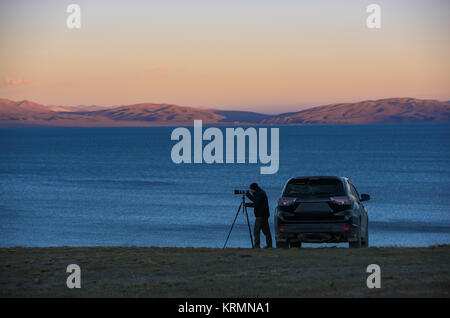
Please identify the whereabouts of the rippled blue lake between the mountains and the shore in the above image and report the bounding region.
[0,125,450,247]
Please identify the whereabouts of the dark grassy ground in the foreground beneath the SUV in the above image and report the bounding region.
[0,245,450,297]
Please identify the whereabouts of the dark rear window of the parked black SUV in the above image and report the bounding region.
[283,178,345,198]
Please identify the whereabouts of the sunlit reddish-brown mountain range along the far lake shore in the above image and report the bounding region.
[0,98,450,127]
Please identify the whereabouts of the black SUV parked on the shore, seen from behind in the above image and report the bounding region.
[275,177,370,247]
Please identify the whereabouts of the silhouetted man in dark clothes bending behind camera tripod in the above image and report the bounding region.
[245,183,272,248]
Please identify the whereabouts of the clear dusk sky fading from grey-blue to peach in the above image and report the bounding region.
[0,0,450,113]
